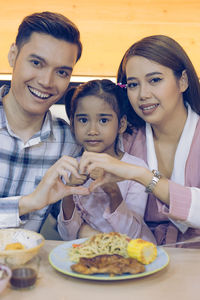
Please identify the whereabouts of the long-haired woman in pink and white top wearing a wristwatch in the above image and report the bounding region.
[80,35,200,246]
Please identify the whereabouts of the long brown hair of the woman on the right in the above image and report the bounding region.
[117,35,200,127]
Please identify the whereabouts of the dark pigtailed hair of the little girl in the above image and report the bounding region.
[65,79,132,154]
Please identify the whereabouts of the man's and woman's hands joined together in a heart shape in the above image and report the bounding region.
[28,152,127,214]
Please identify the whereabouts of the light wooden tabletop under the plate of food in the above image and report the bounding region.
[0,241,200,300]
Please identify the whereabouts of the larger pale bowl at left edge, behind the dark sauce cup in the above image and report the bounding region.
[0,228,45,265]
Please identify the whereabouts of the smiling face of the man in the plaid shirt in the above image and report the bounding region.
[10,33,78,116]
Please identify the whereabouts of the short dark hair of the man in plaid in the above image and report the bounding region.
[16,11,82,61]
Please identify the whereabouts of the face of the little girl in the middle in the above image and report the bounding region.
[74,96,126,156]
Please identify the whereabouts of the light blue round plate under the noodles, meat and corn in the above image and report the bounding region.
[49,239,169,281]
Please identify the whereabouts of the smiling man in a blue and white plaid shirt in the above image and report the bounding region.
[0,12,82,231]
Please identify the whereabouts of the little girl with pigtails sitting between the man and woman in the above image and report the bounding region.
[58,80,155,242]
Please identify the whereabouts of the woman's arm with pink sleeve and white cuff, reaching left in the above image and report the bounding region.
[80,152,200,228]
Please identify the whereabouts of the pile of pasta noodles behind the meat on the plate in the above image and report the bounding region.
[69,232,130,262]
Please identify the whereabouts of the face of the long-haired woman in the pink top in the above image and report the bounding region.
[126,56,188,126]
